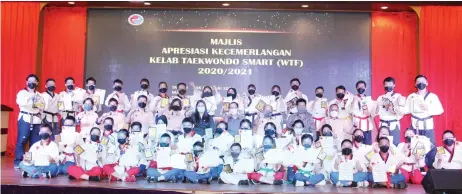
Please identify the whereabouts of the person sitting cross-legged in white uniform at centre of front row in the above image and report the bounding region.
[218,143,254,185]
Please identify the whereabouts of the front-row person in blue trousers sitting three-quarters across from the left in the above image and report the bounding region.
[330,139,369,187]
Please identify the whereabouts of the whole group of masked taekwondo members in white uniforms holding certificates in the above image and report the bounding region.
[15,74,462,188]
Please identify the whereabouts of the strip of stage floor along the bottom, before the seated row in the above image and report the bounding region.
[1,156,425,194]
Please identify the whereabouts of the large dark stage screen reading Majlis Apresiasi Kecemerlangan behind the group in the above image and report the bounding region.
[85,9,371,99]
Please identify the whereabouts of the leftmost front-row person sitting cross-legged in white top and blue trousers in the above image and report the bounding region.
[19,124,59,179]
